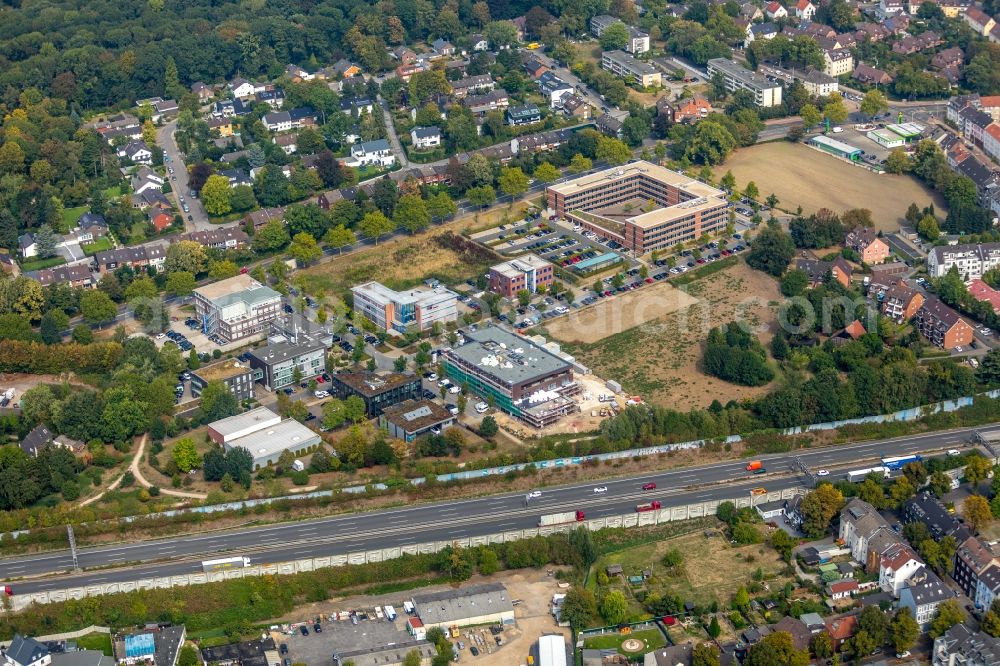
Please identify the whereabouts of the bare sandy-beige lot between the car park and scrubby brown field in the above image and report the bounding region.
[548,282,698,344]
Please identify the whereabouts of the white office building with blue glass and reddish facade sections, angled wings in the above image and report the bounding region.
[351,282,458,334]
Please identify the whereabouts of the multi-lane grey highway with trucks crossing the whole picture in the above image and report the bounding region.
[0,429,973,594]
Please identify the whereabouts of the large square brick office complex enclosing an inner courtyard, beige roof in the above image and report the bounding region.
[545,161,729,254]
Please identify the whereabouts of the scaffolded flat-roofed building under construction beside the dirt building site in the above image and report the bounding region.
[443,327,580,428]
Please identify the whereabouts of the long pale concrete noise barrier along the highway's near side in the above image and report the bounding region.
[9,487,808,611]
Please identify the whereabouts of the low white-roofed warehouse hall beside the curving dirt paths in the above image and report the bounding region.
[208,407,321,469]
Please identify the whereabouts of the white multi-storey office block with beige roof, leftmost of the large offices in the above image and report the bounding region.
[194,275,281,342]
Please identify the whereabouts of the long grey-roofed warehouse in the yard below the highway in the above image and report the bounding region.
[413,583,514,629]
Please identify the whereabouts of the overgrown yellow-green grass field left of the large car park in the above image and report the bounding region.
[296,229,500,295]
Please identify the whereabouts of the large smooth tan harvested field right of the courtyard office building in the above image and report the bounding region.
[715,141,947,231]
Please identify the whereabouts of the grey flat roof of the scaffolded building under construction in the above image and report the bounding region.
[448,326,570,385]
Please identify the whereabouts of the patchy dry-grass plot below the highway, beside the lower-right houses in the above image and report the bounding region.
[588,526,786,611]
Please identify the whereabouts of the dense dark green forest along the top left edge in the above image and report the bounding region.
[0,0,609,109]
